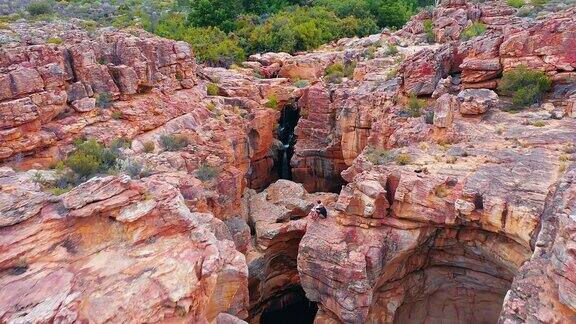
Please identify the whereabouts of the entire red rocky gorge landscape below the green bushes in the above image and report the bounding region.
[0,0,576,324]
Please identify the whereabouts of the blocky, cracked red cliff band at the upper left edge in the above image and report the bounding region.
[0,28,197,159]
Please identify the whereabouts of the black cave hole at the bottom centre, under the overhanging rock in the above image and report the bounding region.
[260,285,318,324]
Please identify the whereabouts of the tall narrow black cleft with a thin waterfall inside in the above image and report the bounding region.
[275,103,300,180]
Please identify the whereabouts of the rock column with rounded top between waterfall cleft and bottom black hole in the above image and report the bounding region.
[244,180,336,323]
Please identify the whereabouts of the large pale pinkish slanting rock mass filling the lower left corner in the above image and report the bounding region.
[0,168,248,323]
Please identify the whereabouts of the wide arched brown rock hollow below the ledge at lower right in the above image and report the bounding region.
[371,229,530,324]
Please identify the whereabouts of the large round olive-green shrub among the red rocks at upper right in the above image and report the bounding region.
[498,65,552,107]
